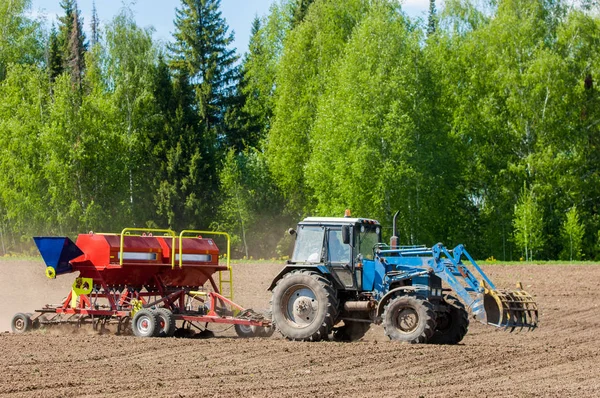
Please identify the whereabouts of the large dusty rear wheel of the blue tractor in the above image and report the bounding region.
[271,270,338,341]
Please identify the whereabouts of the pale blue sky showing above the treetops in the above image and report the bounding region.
[31,0,432,54]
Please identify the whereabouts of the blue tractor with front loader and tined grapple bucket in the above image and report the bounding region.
[269,213,538,344]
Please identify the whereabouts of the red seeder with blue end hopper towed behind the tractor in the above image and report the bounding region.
[12,228,272,337]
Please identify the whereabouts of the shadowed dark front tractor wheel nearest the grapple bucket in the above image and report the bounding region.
[429,296,469,344]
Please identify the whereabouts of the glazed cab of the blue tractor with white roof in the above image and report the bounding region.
[289,217,381,290]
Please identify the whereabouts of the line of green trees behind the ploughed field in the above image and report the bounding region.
[0,0,600,260]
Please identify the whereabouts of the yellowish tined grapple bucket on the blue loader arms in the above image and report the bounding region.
[484,283,538,332]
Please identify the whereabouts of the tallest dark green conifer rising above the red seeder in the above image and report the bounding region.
[164,0,239,228]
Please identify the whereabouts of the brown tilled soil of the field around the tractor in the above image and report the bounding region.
[0,260,600,397]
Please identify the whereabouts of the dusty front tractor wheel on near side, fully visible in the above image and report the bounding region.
[383,296,435,344]
